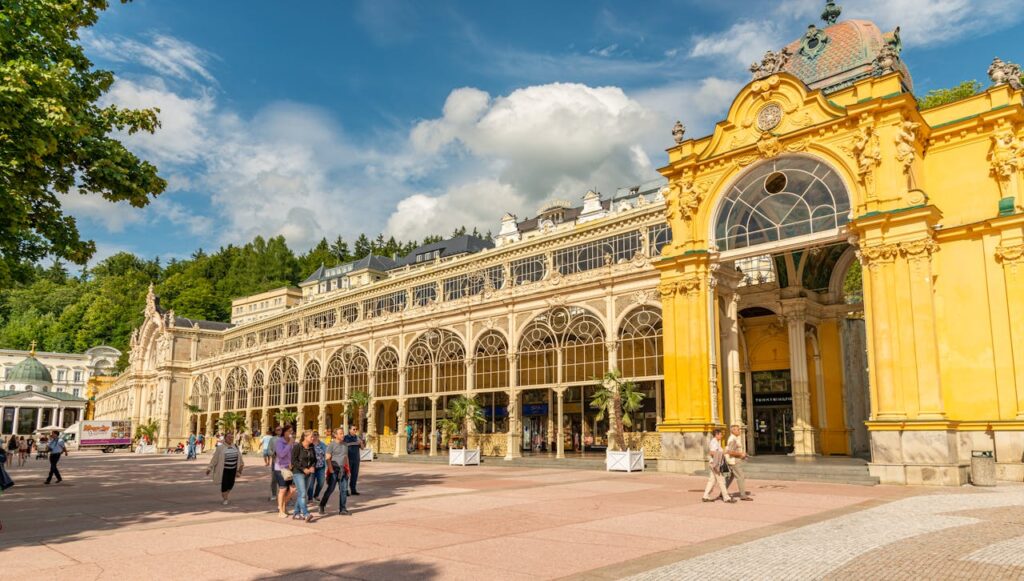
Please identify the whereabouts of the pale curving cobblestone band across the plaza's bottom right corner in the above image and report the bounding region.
[630,488,1024,581]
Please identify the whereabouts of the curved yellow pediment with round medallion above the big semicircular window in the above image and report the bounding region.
[693,73,845,161]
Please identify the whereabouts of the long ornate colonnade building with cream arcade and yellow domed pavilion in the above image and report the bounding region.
[96,4,1024,486]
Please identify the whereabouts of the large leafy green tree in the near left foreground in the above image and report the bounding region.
[0,0,167,286]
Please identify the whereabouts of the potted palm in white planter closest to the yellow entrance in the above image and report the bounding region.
[590,370,644,472]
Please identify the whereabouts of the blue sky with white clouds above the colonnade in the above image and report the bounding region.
[67,0,1024,258]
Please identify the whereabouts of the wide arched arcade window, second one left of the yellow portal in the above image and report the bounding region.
[518,306,608,385]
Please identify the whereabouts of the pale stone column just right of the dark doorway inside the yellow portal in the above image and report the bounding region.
[782,299,818,456]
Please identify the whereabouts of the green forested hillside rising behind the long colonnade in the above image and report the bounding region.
[0,227,490,363]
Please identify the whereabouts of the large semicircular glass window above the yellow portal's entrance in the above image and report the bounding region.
[715,156,850,252]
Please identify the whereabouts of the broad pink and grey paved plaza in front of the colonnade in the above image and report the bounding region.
[0,453,1024,581]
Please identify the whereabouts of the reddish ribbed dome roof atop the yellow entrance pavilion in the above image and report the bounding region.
[782,19,912,93]
